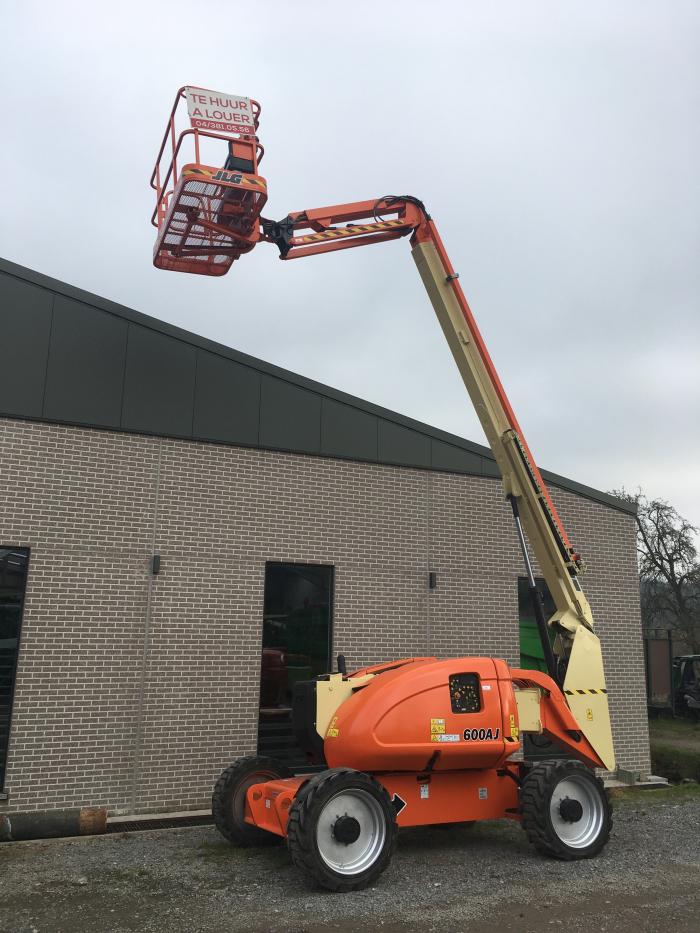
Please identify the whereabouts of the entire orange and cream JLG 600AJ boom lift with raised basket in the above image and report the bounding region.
[151,87,615,891]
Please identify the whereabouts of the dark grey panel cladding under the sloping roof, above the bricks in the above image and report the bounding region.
[0,259,634,512]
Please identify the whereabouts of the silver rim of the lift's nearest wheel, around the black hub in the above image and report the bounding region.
[316,787,386,875]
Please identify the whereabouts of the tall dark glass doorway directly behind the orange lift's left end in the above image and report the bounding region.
[258,563,333,767]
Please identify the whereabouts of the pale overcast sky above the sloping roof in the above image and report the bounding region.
[0,0,700,524]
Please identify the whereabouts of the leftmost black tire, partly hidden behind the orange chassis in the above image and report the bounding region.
[211,755,292,846]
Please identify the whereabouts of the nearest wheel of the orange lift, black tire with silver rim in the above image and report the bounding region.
[287,768,398,892]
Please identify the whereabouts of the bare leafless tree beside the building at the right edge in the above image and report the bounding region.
[612,489,700,653]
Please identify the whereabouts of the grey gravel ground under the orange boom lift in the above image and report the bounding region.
[0,789,700,933]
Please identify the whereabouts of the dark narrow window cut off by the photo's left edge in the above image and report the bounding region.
[0,548,29,789]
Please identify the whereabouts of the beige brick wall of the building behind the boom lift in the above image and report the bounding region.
[0,419,649,812]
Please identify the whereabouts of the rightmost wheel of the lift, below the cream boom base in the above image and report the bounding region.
[520,759,612,862]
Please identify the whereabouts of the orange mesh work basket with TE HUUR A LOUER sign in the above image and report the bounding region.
[151,86,267,275]
